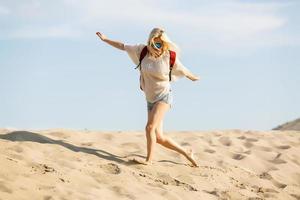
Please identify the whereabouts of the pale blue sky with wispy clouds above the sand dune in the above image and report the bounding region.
[0,0,300,131]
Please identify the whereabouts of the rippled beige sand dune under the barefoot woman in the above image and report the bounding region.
[0,129,300,200]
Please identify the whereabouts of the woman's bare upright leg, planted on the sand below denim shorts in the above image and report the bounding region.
[146,101,170,163]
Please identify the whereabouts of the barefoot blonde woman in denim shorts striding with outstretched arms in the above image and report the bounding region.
[96,28,199,167]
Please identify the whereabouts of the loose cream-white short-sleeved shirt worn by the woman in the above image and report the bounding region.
[124,44,189,103]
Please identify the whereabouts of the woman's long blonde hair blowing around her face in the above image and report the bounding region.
[147,28,180,56]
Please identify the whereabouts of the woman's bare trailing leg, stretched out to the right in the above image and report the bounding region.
[155,120,198,167]
